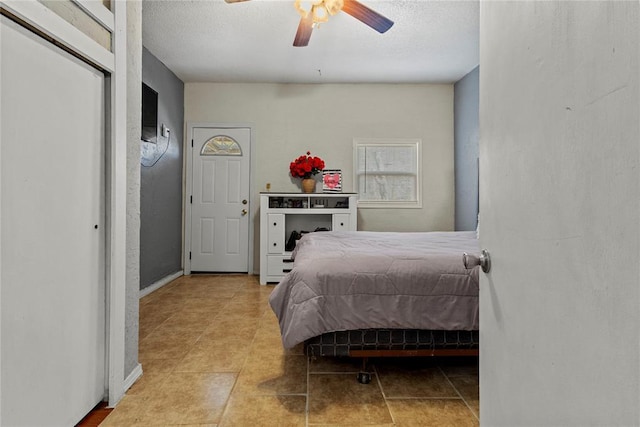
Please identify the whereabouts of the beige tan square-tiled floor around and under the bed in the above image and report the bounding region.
[101,275,479,427]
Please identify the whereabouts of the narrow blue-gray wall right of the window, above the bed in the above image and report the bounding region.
[454,66,480,231]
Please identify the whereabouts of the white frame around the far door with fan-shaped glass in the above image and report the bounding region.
[182,122,258,275]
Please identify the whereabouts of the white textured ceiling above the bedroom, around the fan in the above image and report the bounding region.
[142,0,479,83]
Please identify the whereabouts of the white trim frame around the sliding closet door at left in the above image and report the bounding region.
[0,0,127,412]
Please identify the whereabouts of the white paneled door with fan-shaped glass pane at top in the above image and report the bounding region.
[191,127,251,272]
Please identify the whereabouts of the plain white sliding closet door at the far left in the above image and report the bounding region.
[0,16,105,426]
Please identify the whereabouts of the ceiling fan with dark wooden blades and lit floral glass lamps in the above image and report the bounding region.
[225,0,393,47]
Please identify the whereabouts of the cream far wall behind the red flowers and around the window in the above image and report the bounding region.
[185,83,454,269]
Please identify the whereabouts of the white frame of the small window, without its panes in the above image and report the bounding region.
[353,138,422,209]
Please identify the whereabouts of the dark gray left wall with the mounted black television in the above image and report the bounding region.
[140,47,184,289]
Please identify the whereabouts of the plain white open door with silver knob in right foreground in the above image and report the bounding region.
[480,1,640,427]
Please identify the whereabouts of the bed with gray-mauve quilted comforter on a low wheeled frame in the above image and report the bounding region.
[269,231,479,382]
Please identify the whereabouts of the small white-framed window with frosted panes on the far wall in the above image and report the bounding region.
[353,138,422,208]
